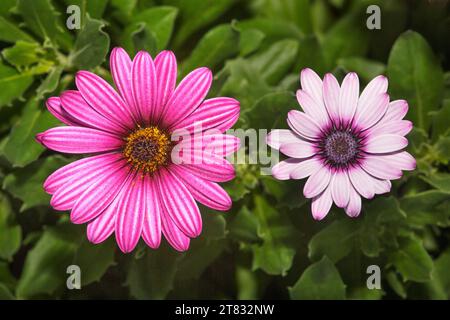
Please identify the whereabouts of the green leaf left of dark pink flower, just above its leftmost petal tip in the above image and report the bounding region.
[3,99,58,167]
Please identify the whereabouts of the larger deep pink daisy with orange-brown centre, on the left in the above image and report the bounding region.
[36,48,240,252]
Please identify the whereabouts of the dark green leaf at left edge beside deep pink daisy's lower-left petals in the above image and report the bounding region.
[3,156,68,211]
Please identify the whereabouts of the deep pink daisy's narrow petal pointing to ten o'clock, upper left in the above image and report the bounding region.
[61,90,125,134]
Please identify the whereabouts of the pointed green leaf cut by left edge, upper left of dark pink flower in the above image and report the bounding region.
[0,62,33,107]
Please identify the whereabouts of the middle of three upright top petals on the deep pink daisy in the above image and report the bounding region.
[131,51,158,124]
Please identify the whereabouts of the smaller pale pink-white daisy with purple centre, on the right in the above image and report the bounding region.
[267,69,416,220]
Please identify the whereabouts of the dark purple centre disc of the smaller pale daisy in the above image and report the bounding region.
[323,131,359,166]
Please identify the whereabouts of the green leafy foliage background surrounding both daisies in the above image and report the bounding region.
[0,0,450,299]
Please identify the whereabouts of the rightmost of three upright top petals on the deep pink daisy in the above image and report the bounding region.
[153,51,177,121]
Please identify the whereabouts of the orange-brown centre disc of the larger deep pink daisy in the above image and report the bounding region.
[123,127,171,173]
